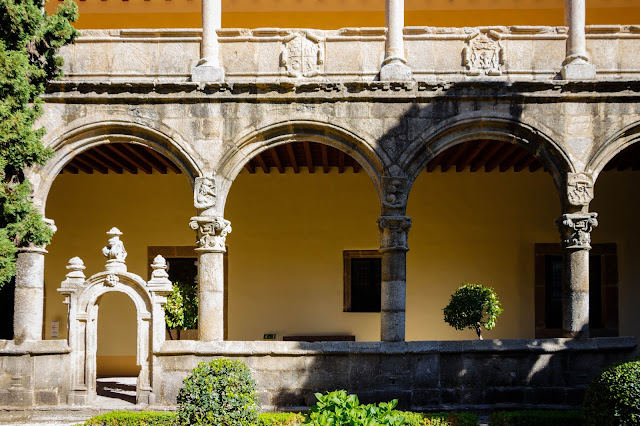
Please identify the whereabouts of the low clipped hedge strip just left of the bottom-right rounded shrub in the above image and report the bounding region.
[489,410,584,426]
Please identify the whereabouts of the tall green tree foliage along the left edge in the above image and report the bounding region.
[0,0,78,287]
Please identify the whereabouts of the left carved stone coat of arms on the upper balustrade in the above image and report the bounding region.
[280,32,324,77]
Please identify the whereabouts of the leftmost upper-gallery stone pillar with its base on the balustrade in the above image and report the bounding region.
[191,0,224,81]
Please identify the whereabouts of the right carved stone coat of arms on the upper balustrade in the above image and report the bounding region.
[462,33,506,75]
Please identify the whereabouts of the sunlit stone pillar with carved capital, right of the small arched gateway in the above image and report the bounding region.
[190,216,231,341]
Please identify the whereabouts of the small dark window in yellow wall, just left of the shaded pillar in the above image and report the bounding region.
[343,250,382,312]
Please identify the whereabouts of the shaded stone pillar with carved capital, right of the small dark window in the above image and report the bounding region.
[378,216,411,342]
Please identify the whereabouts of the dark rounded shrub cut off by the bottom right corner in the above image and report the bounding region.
[584,359,640,426]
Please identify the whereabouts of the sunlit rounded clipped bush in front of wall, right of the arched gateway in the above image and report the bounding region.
[177,359,258,426]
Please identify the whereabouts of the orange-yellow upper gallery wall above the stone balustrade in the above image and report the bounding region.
[46,0,640,29]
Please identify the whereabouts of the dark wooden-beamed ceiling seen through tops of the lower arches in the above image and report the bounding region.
[61,140,640,174]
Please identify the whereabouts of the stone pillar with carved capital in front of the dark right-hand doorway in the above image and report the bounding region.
[556,213,598,337]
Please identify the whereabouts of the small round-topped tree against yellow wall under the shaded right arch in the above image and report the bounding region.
[443,283,502,340]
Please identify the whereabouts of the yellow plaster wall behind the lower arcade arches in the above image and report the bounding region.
[45,166,640,362]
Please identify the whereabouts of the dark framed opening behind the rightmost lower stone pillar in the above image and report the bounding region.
[535,244,618,338]
